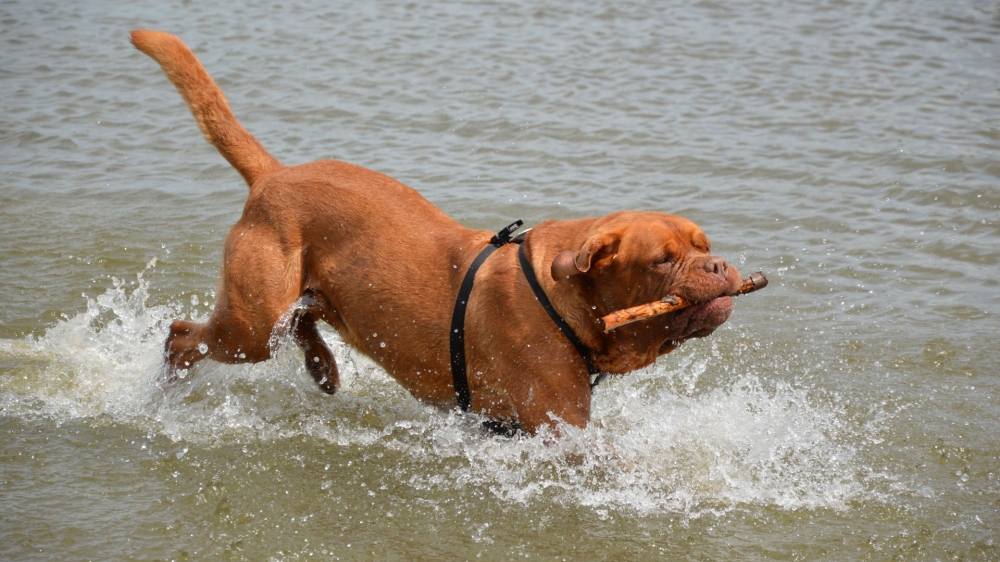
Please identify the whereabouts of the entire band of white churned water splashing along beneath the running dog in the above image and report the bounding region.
[0,259,892,517]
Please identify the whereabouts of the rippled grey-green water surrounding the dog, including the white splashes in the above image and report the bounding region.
[0,0,1000,560]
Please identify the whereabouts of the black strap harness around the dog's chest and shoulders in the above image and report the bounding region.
[451,220,607,412]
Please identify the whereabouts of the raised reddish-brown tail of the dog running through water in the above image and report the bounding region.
[132,30,283,187]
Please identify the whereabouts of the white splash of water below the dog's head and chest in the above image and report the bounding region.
[386,367,870,517]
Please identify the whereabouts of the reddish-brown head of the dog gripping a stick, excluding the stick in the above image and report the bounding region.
[551,211,741,372]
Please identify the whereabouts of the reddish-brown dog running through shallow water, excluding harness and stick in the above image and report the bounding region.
[132,31,740,433]
